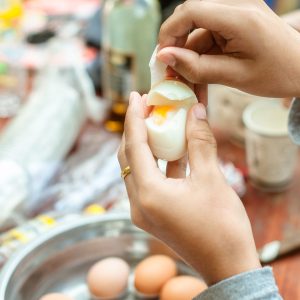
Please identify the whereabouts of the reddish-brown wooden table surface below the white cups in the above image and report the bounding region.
[0,119,300,300]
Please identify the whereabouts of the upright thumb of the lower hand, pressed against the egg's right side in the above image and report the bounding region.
[186,103,217,173]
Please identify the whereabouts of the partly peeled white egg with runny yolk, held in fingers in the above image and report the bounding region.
[145,79,198,161]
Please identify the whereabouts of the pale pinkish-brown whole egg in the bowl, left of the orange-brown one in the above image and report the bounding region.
[87,257,130,299]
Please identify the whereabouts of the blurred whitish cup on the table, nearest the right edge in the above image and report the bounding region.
[243,100,298,191]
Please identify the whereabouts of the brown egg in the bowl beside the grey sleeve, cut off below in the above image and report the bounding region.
[160,275,207,300]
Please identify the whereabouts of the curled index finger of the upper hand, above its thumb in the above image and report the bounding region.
[159,1,243,49]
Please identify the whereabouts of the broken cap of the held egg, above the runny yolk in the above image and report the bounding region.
[147,79,198,106]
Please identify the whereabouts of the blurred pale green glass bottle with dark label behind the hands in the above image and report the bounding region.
[102,0,161,132]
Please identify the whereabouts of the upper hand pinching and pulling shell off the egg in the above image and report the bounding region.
[157,0,300,97]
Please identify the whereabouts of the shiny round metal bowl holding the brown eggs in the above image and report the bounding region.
[0,214,196,300]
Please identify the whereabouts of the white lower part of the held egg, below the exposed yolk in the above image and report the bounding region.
[145,107,187,161]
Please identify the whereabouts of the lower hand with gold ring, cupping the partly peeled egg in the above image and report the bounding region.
[119,93,260,284]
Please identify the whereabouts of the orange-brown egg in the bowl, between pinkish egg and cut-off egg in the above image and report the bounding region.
[134,255,177,295]
